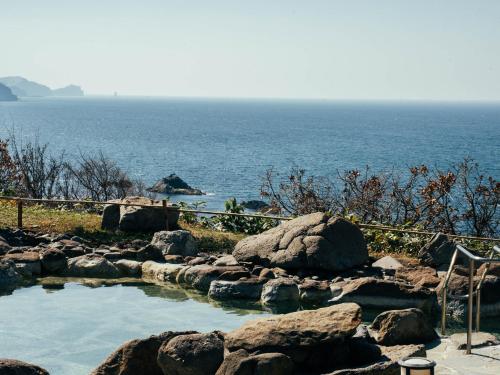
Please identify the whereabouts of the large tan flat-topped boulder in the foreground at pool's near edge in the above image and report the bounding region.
[225,303,361,367]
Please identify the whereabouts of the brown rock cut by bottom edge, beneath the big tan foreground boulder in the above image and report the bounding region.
[215,349,294,375]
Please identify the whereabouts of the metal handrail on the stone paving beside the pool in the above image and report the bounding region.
[441,244,500,354]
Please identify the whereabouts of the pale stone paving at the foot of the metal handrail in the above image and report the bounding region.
[427,335,500,375]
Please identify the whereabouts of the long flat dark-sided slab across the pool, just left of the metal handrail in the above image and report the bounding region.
[331,277,437,312]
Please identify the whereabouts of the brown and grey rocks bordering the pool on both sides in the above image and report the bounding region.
[0,213,500,375]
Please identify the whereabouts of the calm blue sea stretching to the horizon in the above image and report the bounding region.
[0,97,500,208]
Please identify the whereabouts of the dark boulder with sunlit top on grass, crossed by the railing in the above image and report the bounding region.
[101,197,179,232]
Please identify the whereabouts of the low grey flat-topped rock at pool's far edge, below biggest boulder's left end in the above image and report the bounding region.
[208,278,262,300]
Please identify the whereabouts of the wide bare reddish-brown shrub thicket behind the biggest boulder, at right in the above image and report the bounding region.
[261,159,500,236]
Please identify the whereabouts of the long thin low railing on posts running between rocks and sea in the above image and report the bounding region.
[0,196,500,243]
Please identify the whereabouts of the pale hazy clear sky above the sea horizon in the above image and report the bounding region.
[0,0,500,100]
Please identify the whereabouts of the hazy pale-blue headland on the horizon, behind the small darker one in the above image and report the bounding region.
[0,76,83,97]
